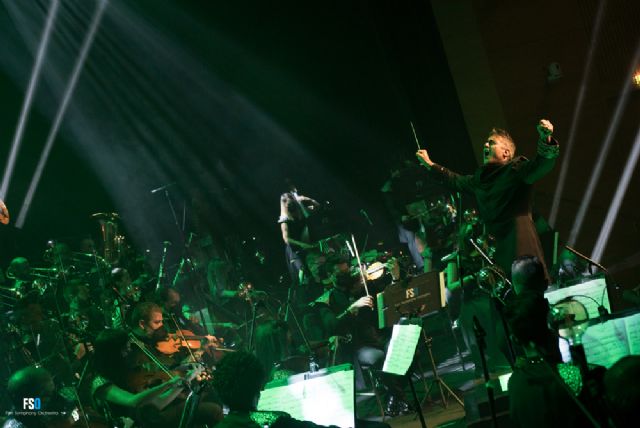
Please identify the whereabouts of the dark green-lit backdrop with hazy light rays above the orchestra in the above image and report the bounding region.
[0,1,474,270]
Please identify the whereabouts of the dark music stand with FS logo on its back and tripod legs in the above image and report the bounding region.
[376,272,464,408]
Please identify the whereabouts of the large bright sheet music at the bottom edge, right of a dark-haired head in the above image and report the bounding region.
[258,366,355,428]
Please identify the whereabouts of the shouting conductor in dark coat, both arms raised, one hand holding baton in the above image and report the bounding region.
[416,119,559,277]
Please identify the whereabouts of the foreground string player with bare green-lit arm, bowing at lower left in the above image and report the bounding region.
[91,330,222,427]
